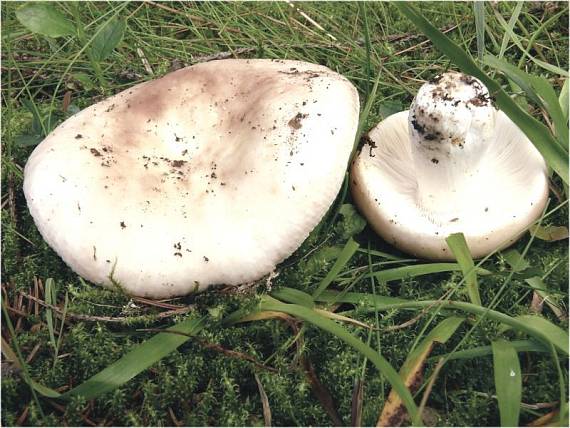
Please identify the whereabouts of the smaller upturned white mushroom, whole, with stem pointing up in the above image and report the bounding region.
[351,73,548,260]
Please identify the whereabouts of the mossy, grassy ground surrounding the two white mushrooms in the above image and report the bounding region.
[1,2,568,426]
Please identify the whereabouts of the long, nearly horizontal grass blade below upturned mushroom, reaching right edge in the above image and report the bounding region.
[316,291,568,355]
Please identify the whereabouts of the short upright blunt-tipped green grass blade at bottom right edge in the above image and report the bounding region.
[491,340,522,427]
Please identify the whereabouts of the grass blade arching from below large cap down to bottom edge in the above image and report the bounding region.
[255,300,418,420]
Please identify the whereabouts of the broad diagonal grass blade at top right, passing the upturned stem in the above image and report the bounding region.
[395,2,569,184]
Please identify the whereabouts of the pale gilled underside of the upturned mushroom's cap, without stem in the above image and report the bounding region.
[352,111,547,258]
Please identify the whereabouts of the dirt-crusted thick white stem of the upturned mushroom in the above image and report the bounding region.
[408,73,495,215]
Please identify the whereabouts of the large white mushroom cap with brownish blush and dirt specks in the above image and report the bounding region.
[24,60,359,297]
